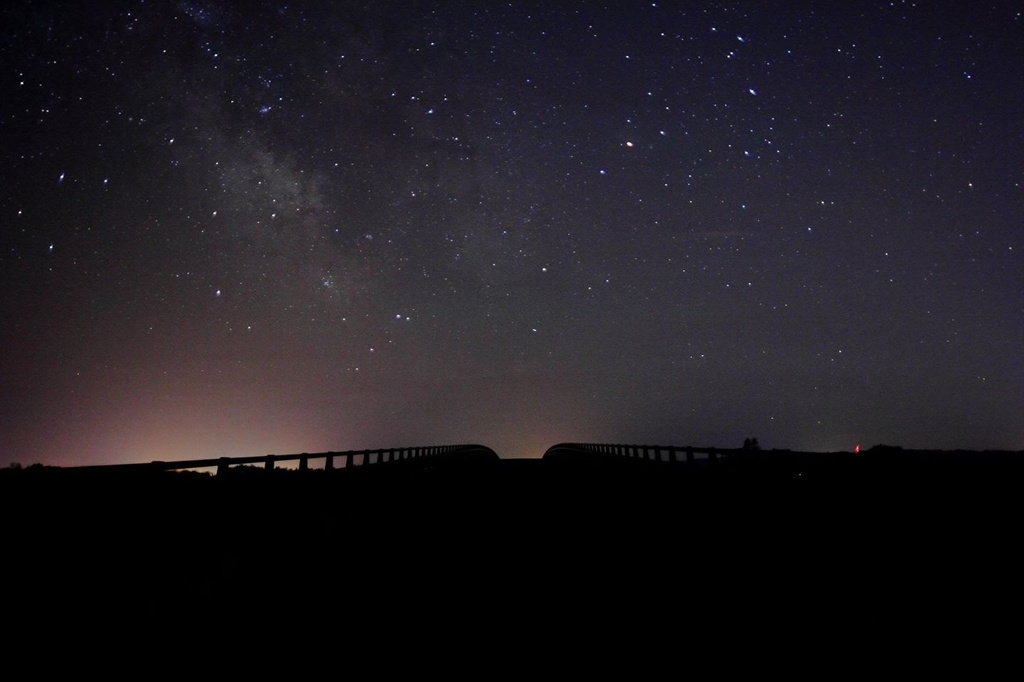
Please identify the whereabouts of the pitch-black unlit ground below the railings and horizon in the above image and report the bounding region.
[0,453,1024,677]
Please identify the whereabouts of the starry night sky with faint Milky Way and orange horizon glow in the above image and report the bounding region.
[0,0,1024,466]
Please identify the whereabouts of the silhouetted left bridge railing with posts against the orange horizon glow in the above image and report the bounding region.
[74,444,498,476]
